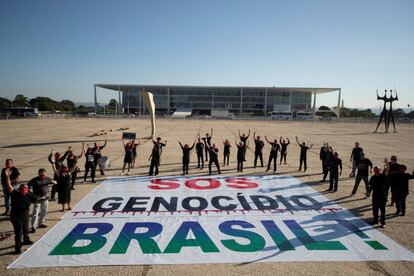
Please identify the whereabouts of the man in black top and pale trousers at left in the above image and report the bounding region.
[27,169,56,233]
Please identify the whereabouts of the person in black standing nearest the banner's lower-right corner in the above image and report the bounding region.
[368,166,386,228]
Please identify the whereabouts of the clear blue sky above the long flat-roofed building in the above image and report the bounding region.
[0,0,414,108]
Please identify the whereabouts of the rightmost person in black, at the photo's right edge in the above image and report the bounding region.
[389,165,414,216]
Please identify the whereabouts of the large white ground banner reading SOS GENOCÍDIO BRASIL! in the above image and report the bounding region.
[9,176,414,268]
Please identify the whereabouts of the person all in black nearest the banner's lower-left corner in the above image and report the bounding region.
[4,168,36,254]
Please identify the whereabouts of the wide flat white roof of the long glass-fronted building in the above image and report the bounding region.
[95,83,341,94]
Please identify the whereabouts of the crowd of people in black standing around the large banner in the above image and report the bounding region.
[1,129,414,254]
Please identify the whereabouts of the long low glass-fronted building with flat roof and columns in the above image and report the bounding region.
[94,84,341,116]
